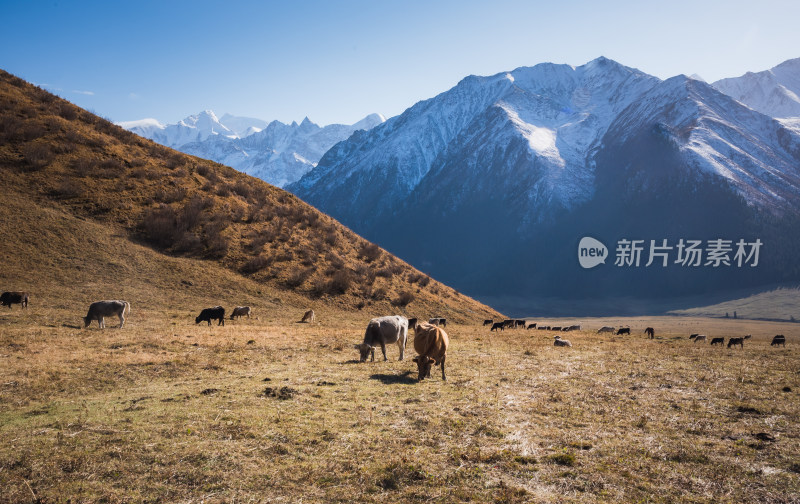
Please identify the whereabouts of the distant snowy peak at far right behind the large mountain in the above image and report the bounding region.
[713,58,800,118]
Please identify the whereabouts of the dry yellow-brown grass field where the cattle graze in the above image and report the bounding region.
[0,310,800,503]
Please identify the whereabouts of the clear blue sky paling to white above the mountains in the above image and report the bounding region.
[0,0,800,125]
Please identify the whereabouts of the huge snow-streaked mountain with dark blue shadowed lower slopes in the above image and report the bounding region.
[288,58,800,304]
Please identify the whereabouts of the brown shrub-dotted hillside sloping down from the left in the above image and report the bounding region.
[0,71,498,321]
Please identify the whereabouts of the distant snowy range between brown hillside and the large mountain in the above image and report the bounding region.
[119,110,385,187]
